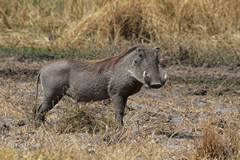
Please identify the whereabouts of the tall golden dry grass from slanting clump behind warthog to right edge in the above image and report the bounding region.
[55,0,240,54]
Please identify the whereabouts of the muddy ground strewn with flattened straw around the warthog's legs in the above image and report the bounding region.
[0,57,240,160]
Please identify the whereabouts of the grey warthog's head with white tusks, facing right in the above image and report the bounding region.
[128,47,167,88]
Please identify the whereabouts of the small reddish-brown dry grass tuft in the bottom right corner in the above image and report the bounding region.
[195,124,240,159]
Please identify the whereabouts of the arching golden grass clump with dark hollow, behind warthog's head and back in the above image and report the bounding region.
[54,1,151,47]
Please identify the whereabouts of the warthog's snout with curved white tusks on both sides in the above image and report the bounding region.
[143,71,167,89]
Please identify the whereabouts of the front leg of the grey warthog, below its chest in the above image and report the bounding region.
[112,95,127,128]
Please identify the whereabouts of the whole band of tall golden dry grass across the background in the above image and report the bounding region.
[0,0,240,62]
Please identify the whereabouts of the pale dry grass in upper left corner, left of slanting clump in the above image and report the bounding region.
[0,0,106,48]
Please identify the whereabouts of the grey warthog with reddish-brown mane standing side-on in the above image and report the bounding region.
[34,45,167,127]
